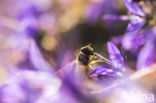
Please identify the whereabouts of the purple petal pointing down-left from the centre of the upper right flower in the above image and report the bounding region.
[127,16,146,33]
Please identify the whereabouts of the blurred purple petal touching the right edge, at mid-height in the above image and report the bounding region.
[137,27,156,69]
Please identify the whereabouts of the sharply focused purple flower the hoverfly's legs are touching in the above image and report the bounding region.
[90,42,126,79]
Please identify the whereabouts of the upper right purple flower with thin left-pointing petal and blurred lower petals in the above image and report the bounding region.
[104,0,147,50]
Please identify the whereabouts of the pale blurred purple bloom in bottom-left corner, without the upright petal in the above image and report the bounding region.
[0,71,80,103]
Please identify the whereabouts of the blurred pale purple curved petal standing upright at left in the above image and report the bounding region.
[29,40,53,71]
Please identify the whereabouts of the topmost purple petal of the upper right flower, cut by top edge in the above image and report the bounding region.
[124,0,145,16]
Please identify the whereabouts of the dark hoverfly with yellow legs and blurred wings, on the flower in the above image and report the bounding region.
[57,44,111,77]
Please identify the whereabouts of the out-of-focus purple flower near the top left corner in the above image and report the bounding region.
[15,1,44,37]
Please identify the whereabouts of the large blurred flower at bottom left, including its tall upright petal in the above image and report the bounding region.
[0,39,82,103]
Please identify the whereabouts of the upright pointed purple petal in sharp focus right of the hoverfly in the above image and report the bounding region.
[107,42,125,70]
